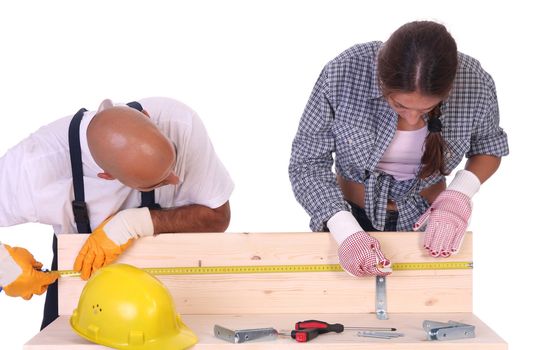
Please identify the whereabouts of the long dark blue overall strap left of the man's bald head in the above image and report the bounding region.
[69,108,91,233]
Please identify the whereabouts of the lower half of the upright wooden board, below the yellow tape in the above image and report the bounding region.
[60,271,472,315]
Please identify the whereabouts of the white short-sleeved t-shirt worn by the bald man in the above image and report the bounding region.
[0,97,234,233]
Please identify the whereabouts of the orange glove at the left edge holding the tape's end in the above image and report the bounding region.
[0,245,60,300]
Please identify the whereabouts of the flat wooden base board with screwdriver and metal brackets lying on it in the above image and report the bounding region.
[24,313,507,350]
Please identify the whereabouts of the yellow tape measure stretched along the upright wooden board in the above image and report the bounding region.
[57,261,473,277]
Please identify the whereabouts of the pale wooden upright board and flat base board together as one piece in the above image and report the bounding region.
[24,232,507,350]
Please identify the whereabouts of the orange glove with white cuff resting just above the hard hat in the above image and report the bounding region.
[73,208,154,280]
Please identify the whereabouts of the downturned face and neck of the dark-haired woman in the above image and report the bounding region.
[387,92,442,128]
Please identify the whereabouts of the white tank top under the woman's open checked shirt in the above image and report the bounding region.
[376,125,428,181]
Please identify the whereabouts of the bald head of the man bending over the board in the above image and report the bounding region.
[87,106,179,191]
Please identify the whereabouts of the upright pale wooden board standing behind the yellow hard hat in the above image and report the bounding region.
[55,232,472,315]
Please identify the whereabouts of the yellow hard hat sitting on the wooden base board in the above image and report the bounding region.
[71,264,197,350]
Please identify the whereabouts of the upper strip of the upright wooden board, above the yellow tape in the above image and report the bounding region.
[58,232,472,270]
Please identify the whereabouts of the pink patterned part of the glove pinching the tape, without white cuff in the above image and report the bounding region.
[339,231,391,276]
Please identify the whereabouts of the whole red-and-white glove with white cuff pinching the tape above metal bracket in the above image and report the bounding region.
[327,211,391,277]
